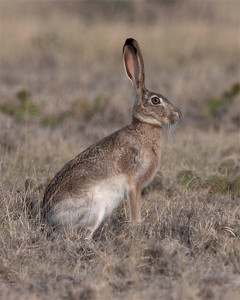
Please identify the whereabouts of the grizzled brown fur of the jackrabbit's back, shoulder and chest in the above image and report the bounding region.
[43,120,161,217]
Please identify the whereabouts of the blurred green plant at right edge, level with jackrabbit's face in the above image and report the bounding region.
[204,83,240,117]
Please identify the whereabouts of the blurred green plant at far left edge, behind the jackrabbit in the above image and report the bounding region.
[0,90,40,121]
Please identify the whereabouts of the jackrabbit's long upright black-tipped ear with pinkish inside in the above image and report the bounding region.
[123,38,144,90]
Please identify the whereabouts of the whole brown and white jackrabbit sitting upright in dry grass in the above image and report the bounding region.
[42,38,181,238]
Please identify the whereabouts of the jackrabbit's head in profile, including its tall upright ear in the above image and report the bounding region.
[123,38,181,126]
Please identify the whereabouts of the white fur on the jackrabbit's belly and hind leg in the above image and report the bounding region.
[48,175,128,231]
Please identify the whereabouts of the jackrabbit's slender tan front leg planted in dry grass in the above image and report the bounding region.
[128,187,141,223]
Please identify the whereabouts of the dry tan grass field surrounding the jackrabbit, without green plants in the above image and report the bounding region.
[0,0,240,299]
